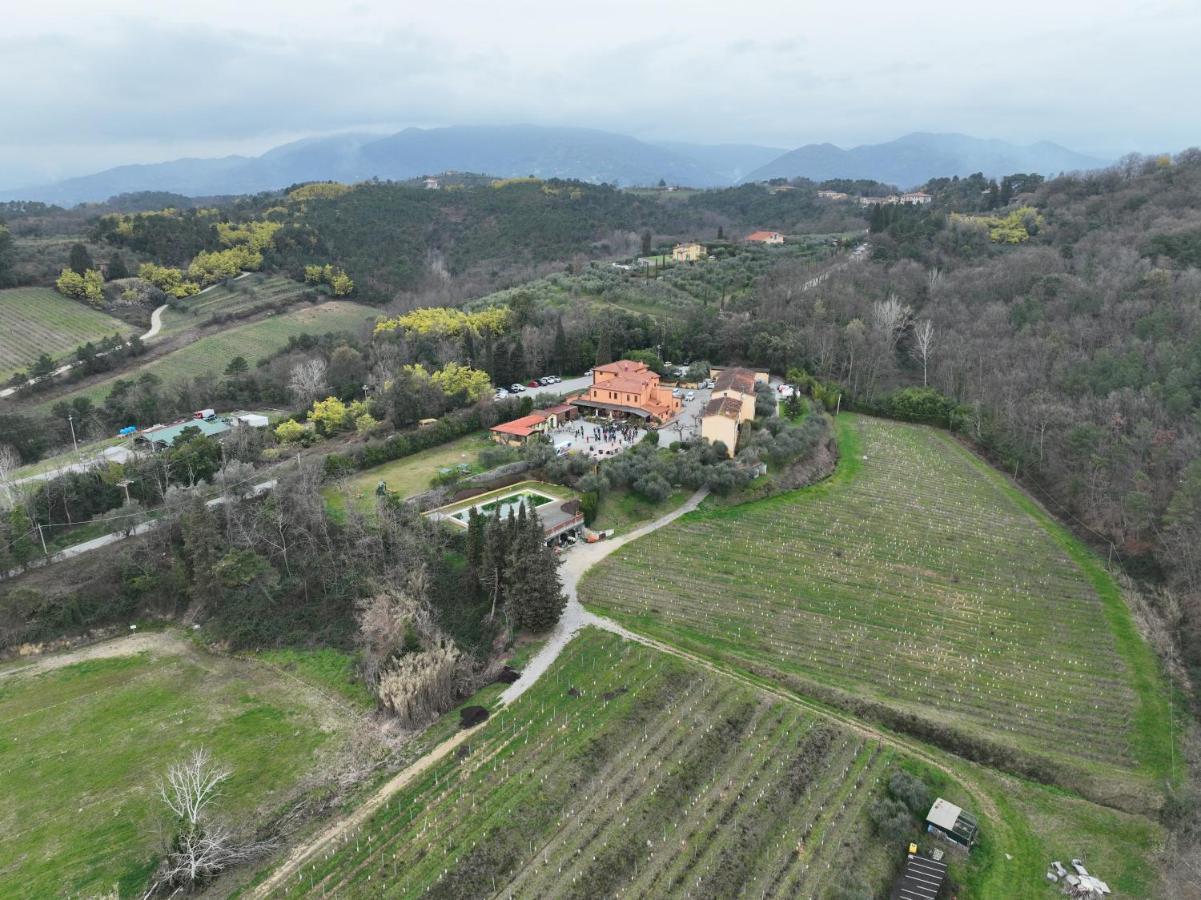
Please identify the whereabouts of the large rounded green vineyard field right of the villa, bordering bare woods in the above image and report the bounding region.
[580,417,1173,809]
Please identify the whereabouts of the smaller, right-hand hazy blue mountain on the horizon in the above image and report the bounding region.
[742,133,1109,187]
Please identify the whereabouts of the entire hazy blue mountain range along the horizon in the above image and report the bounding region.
[0,125,1106,205]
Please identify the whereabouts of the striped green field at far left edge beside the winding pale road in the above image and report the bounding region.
[0,287,136,381]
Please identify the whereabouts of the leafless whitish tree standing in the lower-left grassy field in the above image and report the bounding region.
[144,747,275,898]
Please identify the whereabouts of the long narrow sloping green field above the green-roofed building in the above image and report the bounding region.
[34,300,378,412]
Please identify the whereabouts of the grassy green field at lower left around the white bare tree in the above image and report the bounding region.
[0,634,365,898]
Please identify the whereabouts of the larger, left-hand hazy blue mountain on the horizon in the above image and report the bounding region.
[0,125,736,205]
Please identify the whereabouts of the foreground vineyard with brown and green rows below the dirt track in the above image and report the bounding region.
[272,628,897,898]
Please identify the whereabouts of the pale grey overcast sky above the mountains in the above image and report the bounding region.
[0,0,1201,186]
